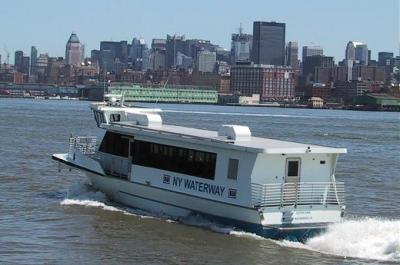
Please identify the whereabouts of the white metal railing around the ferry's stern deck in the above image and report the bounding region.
[251,182,344,207]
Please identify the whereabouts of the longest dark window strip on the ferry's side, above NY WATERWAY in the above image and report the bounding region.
[132,140,217,179]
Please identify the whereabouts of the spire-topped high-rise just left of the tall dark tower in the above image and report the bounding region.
[230,26,253,64]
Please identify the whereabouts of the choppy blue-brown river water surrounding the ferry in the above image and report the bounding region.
[0,99,400,264]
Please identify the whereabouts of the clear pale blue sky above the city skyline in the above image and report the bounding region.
[0,0,400,63]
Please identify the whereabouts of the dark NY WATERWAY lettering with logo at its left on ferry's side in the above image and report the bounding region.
[163,176,225,197]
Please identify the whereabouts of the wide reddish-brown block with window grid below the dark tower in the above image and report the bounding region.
[230,64,296,101]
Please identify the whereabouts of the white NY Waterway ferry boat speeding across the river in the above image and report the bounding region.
[52,100,346,241]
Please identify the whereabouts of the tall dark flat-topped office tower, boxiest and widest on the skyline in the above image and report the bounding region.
[252,21,286,65]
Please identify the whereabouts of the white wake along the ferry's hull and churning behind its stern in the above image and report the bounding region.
[60,183,400,262]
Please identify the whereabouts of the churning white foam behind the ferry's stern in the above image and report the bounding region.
[280,218,400,262]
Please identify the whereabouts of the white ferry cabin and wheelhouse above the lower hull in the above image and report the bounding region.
[92,103,346,207]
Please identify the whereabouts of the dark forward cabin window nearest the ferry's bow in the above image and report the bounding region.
[99,132,129,157]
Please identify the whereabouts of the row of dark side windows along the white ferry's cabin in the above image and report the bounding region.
[99,132,239,180]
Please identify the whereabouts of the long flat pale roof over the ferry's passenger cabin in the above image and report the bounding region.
[103,122,347,154]
